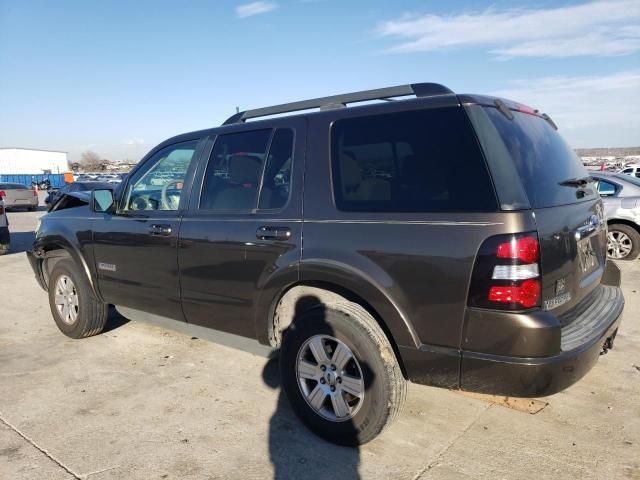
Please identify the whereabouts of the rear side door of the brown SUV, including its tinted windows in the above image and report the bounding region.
[178,119,306,338]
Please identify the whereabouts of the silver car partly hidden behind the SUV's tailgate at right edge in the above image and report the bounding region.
[591,172,640,260]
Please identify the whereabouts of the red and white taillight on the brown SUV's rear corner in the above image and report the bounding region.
[468,232,541,310]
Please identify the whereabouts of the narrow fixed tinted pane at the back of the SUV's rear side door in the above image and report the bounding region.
[258,128,293,209]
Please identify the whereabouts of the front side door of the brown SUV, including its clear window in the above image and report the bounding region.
[93,139,198,320]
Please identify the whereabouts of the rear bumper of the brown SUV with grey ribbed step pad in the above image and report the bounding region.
[400,264,624,397]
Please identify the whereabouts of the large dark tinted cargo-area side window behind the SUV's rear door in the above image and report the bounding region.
[331,108,498,212]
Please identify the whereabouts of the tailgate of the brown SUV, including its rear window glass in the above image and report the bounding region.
[471,106,606,314]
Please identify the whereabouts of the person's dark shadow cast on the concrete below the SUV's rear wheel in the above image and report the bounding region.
[262,299,360,480]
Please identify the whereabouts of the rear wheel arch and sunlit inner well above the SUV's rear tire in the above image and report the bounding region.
[269,282,408,378]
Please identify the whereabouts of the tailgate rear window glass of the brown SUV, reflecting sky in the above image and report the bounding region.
[484,107,597,208]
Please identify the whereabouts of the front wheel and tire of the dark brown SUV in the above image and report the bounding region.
[49,259,109,338]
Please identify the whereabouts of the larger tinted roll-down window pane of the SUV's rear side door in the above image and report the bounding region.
[200,130,271,210]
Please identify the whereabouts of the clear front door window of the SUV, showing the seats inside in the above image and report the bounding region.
[122,140,198,211]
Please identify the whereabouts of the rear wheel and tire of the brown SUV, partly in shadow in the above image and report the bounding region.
[280,303,407,446]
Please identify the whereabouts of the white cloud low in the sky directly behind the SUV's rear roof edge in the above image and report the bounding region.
[491,70,640,147]
